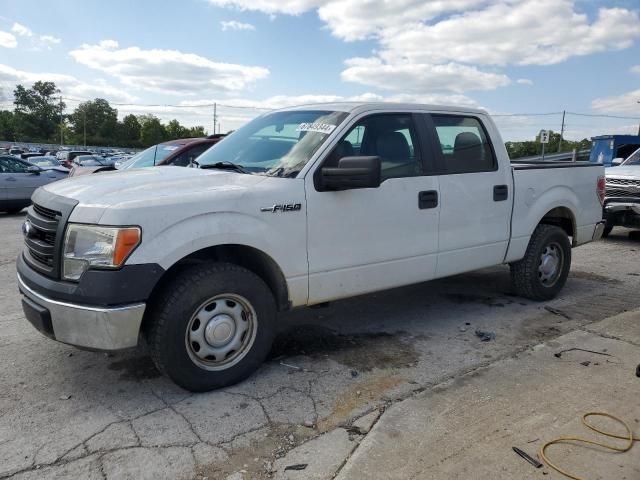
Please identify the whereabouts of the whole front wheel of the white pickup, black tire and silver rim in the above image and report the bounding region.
[146,263,276,392]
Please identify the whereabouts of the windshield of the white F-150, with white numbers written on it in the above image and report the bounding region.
[198,110,347,177]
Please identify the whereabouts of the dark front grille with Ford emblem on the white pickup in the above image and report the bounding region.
[24,203,62,274]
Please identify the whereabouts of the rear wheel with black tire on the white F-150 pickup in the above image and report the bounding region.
[511,224,571,300]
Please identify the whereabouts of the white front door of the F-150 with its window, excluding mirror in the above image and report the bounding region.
[305,113,440,304]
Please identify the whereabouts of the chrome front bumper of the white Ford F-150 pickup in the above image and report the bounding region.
[18,274,146,350]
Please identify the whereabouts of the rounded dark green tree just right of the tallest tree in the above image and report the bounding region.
[69,98,118,145]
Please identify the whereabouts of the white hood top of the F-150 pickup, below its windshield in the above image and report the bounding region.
[42,166,265,208]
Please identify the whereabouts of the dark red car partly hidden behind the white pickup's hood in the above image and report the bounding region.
[71,134,224,177]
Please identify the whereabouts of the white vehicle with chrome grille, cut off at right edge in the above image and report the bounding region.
[603,148,640,236]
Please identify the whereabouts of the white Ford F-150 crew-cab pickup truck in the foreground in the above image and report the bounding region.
[17,103,605,391]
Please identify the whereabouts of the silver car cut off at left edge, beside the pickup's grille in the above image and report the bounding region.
[0,155,67,213]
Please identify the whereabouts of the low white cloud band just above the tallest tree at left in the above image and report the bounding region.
[0,64,137,102]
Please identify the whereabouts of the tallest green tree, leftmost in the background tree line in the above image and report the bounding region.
[13,81,65,141]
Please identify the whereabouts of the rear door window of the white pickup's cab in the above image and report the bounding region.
[431,114,498,173]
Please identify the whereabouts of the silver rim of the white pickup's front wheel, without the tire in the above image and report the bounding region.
[185,293,258,370]
